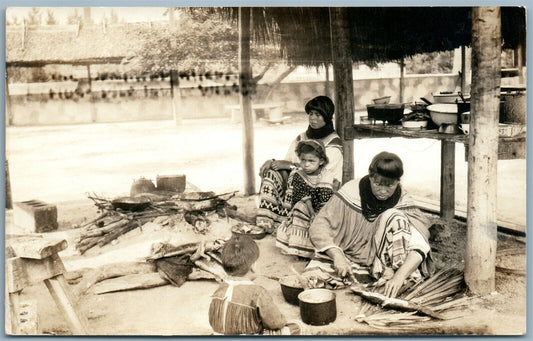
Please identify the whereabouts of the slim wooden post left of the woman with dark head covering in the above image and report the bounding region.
[239,7,255,195]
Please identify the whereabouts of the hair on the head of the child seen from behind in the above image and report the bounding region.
[222,235,259,276]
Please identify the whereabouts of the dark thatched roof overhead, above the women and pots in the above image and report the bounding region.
[216,7,526,65]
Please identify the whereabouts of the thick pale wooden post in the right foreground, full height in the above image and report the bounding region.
[465,7,501,294]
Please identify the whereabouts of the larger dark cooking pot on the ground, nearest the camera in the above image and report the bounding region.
[298,289,337,326]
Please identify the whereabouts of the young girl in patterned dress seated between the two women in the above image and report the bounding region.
[276,140,333,258]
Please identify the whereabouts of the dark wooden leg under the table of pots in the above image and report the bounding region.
[440,140,455,221]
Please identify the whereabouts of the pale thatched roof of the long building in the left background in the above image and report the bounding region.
[6,23,158,65]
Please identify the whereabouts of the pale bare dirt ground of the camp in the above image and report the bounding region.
[6,118,526,335]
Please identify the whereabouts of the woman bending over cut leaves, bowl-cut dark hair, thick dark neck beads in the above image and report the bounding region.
[307,152,433,297]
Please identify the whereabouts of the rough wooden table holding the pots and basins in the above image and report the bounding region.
[344,124,526,220]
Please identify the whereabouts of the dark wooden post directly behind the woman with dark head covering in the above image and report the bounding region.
[329,7,354,184]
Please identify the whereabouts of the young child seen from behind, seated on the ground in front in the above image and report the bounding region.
[209,236,302,335]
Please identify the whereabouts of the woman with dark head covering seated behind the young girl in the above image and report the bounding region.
[256,96,342,233]
